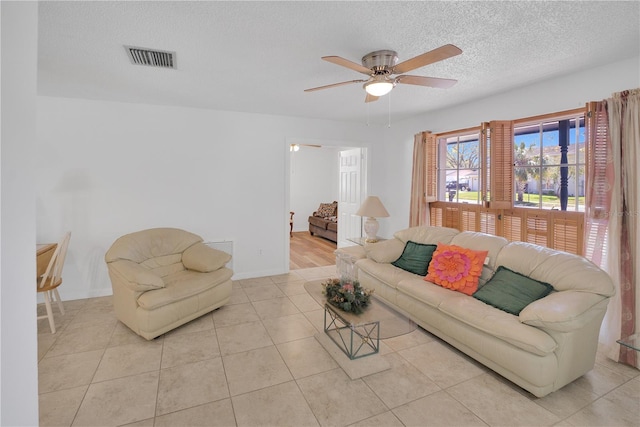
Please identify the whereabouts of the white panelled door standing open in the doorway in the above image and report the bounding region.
[338,148,365,248]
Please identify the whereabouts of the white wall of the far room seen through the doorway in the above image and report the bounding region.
[289,146,340,231]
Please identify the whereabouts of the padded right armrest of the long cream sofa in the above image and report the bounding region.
[519,291,609,332]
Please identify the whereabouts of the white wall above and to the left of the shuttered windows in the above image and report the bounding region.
[371,57,640,237]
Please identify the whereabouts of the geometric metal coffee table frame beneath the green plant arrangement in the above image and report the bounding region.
[324,304,380,360]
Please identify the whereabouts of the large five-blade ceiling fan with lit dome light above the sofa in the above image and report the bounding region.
[305,44,462,102]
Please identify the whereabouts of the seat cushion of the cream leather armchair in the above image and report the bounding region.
[138,268,233,310]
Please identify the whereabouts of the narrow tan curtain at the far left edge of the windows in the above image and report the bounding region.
[409,133,429,227]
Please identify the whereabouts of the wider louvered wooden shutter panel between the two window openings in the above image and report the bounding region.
[488,121,513,209]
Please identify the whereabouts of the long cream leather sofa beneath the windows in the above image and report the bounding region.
[336,227,615,397]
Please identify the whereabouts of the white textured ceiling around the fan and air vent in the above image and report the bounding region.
[38,1,640,124]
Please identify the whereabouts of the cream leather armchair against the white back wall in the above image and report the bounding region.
[105,228,233,340]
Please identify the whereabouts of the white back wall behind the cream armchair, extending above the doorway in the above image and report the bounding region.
[36,97,373,299]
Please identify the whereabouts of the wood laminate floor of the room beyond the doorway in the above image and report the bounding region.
[289,231,337,270]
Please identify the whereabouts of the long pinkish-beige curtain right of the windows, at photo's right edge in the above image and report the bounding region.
[585,89,640,367]
